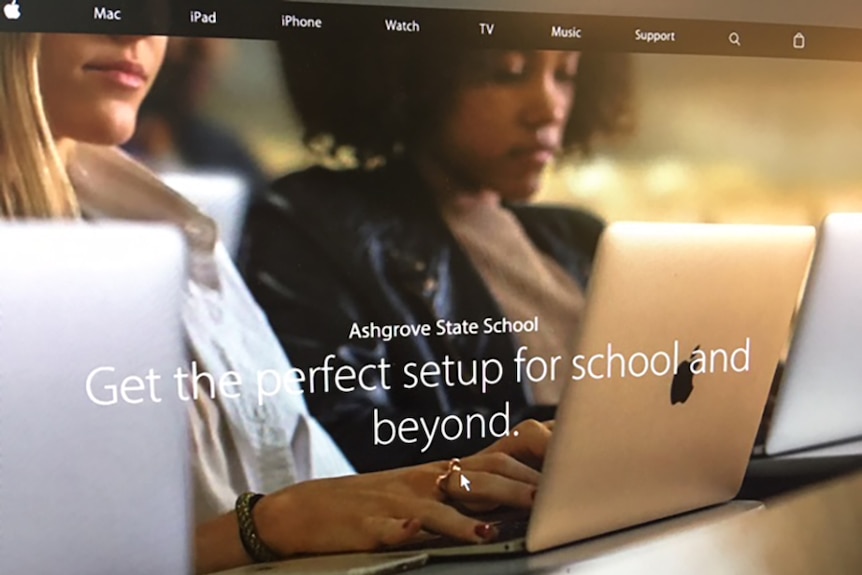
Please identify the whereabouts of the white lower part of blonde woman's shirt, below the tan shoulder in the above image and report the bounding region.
[183,244,353,522]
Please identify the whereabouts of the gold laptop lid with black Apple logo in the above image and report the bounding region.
[527,223,814,551]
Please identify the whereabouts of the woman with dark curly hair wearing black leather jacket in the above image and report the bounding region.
[243,37,630,471]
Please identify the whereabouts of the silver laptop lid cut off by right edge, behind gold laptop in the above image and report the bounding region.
[765,213,862,455]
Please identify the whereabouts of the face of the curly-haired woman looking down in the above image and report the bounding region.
[432,52,579,201]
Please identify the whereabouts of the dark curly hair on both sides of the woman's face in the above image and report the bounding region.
[278,39,633,167]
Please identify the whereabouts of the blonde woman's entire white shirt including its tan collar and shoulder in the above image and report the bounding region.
[68,144,354,523]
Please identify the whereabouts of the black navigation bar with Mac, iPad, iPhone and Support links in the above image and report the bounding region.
[5,0,862,61]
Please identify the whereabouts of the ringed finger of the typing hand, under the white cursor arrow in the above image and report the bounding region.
[443,471,536,509]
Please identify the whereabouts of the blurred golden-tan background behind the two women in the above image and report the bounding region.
[126,36,862,224]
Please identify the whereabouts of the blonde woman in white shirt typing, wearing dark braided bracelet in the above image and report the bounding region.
[0,34,550,573]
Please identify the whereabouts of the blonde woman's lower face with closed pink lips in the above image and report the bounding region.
[39,34,167,145]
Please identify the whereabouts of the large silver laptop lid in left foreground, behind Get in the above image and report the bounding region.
[0,223,192,575]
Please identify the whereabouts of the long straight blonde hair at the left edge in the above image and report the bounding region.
[0,33,79,218]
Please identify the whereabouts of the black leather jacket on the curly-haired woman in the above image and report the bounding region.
[240,162,603,472]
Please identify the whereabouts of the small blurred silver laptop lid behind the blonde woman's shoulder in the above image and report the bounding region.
[159,172,250,258]
